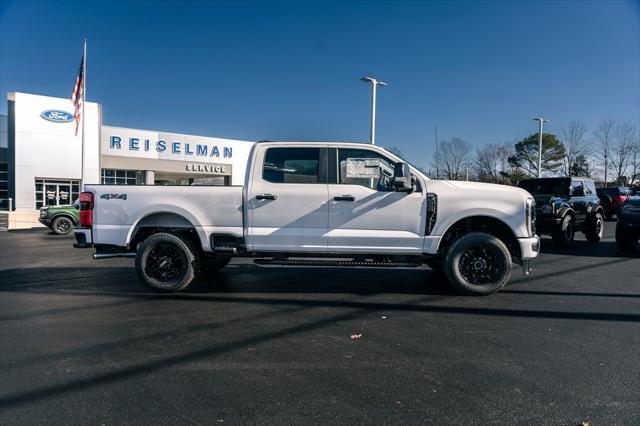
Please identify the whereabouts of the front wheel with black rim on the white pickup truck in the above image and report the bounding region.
[443,232,511,296]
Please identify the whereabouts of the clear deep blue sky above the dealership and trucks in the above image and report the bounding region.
[0,0,640,170]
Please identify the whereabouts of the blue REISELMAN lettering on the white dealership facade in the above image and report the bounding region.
[109,135,233,158]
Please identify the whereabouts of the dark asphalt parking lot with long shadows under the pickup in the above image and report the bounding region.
[0,222,640,425]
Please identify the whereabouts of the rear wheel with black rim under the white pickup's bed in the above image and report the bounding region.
[136,232,199,293]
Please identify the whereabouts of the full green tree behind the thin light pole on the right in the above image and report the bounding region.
[509,133,566,176]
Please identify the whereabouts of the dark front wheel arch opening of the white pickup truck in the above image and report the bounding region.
[437,215,522,259]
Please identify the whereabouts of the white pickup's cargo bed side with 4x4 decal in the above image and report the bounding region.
[85,185,243,251]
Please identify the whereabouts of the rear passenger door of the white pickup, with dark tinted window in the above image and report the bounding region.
[247,147,329,252]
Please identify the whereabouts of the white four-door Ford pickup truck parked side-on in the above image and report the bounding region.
[74,142,539,295]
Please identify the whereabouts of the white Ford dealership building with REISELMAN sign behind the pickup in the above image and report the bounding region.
[0,92,253,228]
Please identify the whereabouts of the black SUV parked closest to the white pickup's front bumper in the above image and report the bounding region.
[518,177,604,247]
